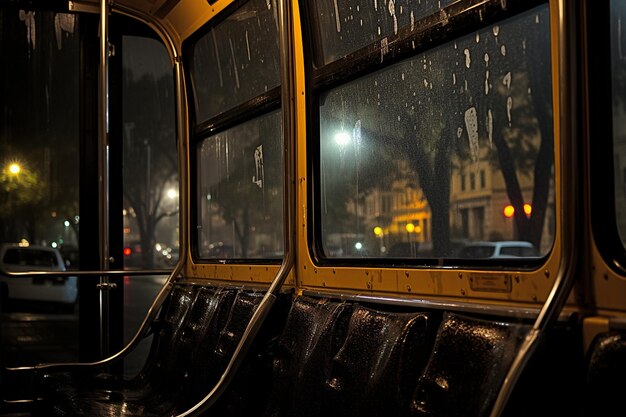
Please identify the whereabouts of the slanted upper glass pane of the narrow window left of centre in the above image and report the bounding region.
[191,0,280,123]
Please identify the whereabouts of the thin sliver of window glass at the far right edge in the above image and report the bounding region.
[611,0,626,247]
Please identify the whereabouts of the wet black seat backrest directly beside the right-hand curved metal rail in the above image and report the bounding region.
[411,312,530,417]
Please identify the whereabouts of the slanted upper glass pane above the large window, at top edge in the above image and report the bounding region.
[313,0,454,64]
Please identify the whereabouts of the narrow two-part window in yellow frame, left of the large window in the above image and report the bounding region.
[190,0,283,262]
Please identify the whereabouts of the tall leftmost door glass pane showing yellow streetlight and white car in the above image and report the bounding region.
[0,7,80,366]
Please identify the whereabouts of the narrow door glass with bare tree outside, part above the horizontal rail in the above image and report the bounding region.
[122,36,179,269]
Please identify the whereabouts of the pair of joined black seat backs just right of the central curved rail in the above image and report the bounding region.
[265,297,432,417]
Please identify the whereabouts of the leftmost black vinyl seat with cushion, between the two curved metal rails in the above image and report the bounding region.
[33,285,263,417]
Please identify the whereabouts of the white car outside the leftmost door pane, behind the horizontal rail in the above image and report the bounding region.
[0,243,78,307]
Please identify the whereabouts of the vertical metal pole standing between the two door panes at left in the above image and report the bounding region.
[98,0,110,357]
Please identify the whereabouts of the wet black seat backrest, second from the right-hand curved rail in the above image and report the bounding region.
[326,305,432,417]
